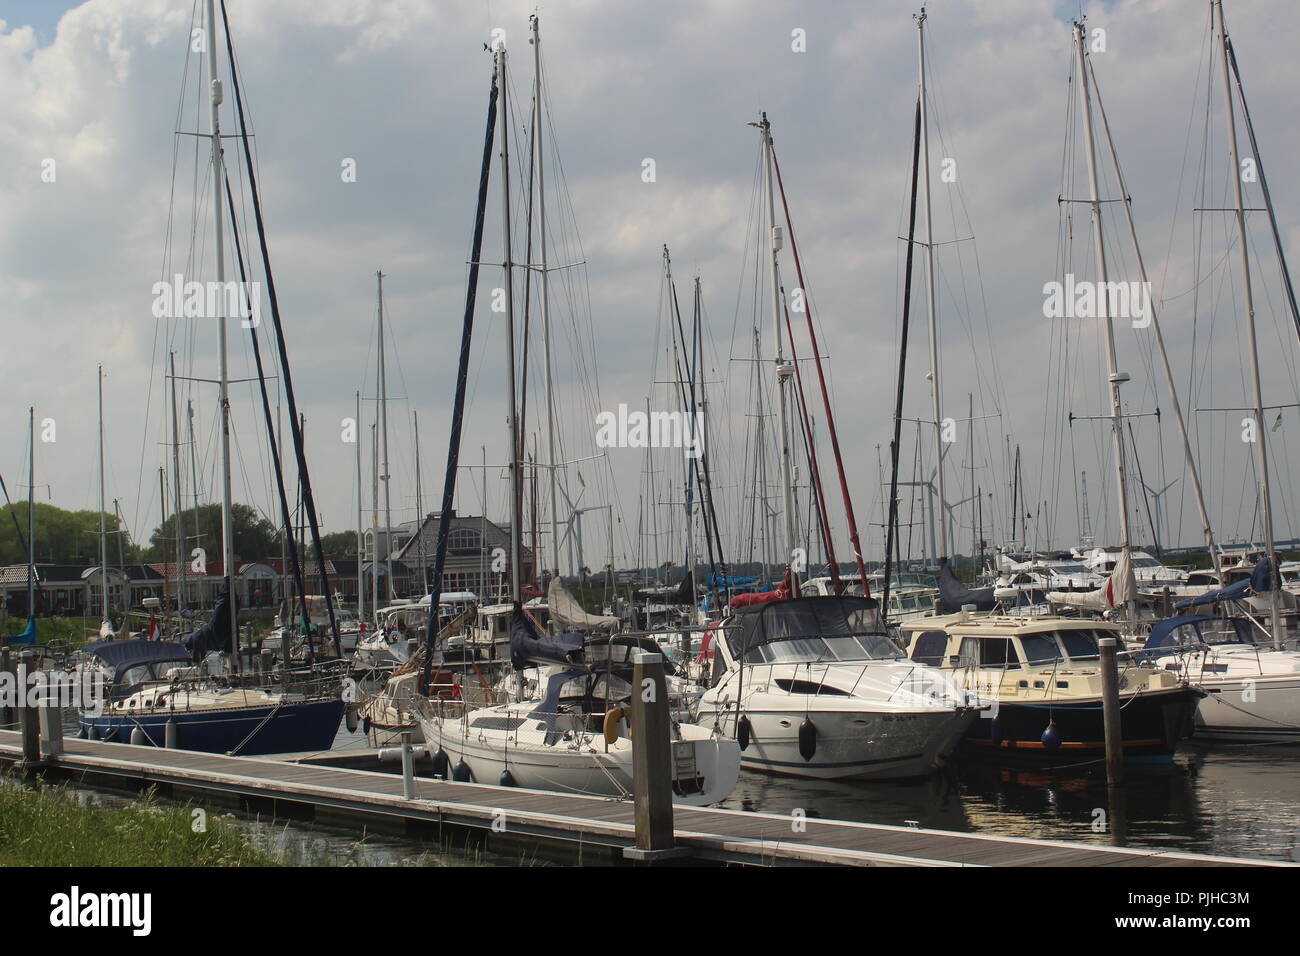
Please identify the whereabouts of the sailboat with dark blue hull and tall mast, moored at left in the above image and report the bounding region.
[78,0,343,754]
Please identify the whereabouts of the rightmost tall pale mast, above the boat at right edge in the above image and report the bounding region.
[1212,0,1282,650]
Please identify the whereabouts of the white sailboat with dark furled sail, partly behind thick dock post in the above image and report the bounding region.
[419,16,740,804]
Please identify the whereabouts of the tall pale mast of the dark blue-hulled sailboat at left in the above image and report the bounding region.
[207,0,239,670]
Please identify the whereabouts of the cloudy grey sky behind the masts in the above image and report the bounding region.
[0,0,1300,566]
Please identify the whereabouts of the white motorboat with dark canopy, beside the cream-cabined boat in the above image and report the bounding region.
[697,592,979,779]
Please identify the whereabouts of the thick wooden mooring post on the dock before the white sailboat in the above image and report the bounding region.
[623,650,689,862]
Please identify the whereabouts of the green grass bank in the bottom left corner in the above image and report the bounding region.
[0,782,281,866]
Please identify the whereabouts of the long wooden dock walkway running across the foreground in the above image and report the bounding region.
[0,731,1290,866]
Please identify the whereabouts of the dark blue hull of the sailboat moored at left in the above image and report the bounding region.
[77,700,343,757]
